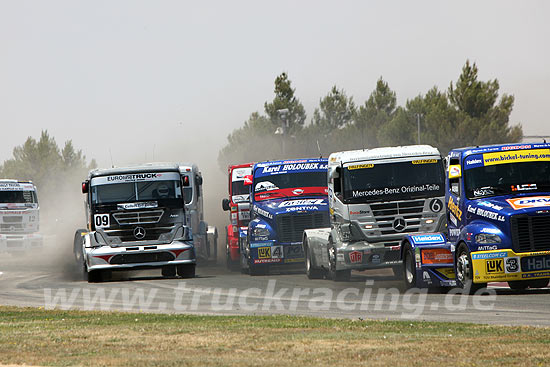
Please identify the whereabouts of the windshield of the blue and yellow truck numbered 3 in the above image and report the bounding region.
[464,161,550,199]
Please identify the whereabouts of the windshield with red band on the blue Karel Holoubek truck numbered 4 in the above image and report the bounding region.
[254,171,327,200]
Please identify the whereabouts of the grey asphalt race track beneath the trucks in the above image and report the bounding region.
[0,254,550,327]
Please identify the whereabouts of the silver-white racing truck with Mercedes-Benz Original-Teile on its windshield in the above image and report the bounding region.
[302,145,446,281]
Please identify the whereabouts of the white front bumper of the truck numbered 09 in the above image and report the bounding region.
[85,241,196,271]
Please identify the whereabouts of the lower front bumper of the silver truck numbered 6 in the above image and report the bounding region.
[336,241,402,270]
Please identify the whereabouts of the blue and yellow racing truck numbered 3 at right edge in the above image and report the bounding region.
[402,143,550,293]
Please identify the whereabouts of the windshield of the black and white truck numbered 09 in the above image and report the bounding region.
[91,180,181,205]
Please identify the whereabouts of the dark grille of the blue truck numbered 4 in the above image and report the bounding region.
[277,213,330,243]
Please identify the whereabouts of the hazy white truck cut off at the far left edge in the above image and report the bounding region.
[0,180,43,254]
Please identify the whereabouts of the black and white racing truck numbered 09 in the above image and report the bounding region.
[74,164,201,282]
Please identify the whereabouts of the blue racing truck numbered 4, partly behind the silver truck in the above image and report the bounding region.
[240,158,330,275]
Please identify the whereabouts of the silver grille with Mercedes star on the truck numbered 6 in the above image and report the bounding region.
[370,200,424,235]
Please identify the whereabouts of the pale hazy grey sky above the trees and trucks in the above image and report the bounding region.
[0,0,550,166]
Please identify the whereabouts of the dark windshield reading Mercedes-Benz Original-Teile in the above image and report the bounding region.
[343,159,445,203]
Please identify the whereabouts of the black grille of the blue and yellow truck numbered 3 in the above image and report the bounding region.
[510,215,550,252]
